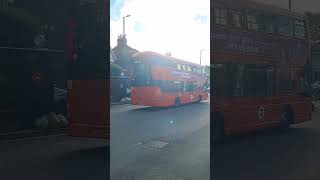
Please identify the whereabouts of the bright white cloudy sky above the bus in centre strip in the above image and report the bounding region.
[110,0,210,65]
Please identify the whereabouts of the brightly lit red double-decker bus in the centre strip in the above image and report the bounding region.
[131,52,209,107]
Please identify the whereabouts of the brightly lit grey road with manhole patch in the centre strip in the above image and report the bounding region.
[110,101,210,180]
